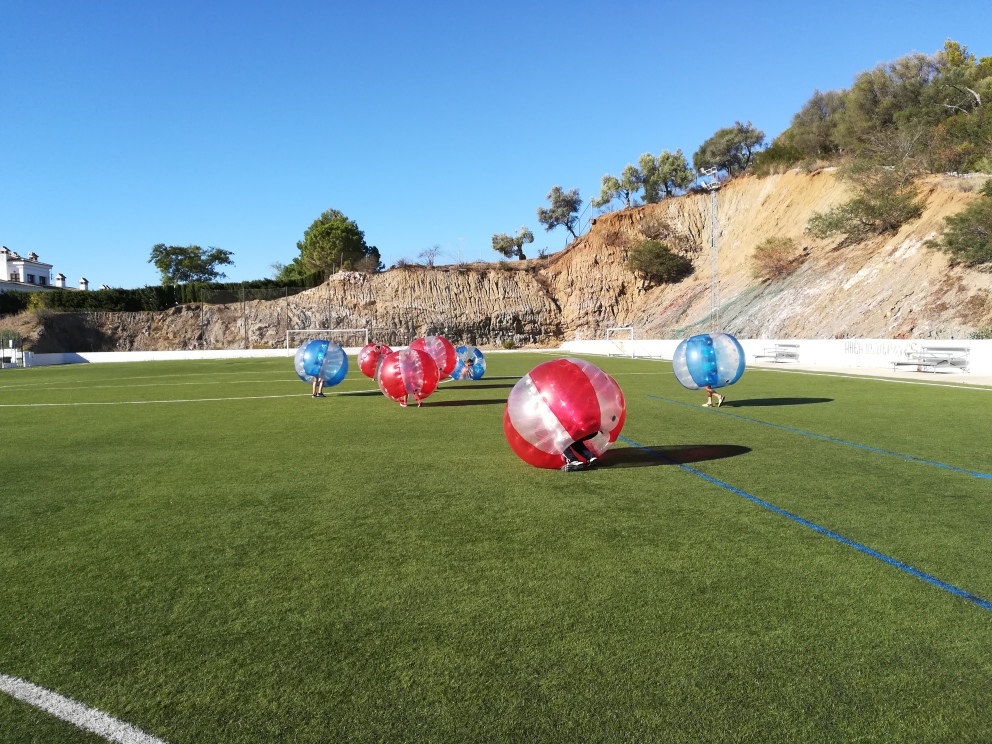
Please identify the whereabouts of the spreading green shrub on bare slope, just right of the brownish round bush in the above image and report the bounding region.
[806,162,923,242]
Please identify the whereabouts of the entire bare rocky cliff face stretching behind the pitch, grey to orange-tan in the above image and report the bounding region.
[9,171,992,352]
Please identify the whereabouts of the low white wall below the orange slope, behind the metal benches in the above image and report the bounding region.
[562,338,992,375]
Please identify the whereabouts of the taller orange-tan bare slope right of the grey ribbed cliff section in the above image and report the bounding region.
[547,172,992,338]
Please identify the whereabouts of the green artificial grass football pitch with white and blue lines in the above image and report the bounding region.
[0,354,992,744]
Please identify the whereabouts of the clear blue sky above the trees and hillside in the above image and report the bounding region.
[0,0,992,287]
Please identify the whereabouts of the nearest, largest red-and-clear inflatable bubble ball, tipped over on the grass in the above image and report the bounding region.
[503,359,627,468]
